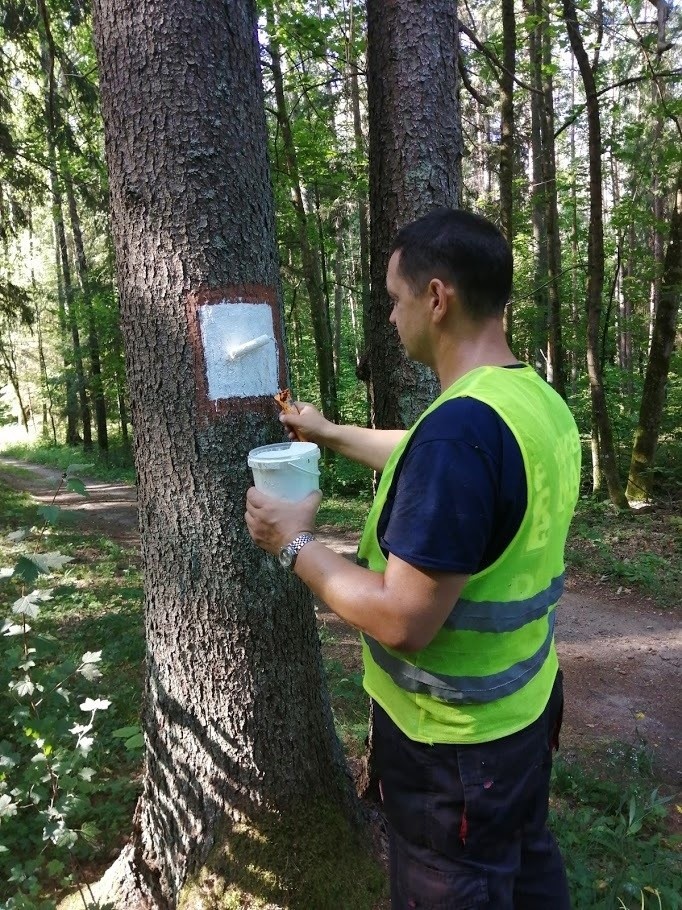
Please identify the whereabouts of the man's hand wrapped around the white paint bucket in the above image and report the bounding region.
[245,487,322,556]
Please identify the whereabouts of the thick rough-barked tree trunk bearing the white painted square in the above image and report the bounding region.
[94,0,370,908]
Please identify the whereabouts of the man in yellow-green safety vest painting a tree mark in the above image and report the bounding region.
[246,209,580,910]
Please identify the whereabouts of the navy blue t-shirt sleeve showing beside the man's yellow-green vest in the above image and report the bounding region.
[377,398,527,574]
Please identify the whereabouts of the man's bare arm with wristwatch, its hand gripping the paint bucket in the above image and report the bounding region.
[246,488,469,652]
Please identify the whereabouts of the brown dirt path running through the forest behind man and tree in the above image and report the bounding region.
[0,458,682,787]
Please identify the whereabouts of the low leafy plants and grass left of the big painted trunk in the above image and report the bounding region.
[0,474,142,910]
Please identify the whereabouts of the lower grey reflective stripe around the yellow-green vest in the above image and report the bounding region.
[363,610,554,705]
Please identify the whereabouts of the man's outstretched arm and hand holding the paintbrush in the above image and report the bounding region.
[279,402,406,471]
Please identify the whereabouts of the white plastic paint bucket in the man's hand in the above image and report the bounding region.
[248,442,320,502]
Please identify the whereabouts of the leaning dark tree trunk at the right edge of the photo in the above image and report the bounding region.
[627,169,682,501]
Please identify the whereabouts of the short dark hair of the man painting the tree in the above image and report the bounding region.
[390,208,513,319]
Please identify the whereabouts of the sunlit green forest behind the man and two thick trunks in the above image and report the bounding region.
[0,0,682,907]
